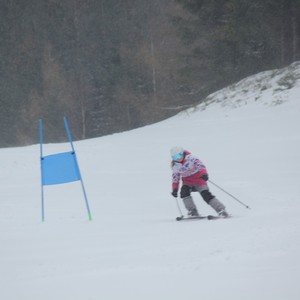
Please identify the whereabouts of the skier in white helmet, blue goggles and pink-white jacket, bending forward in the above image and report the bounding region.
[170,147,229,218]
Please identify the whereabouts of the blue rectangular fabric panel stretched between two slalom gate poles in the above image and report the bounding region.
[42,152,81,185]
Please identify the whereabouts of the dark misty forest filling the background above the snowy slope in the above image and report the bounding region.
[0,0,300,147]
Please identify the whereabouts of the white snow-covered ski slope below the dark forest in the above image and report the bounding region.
[0,64,300,300]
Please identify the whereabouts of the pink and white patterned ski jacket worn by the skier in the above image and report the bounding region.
[172,151,207,190]
